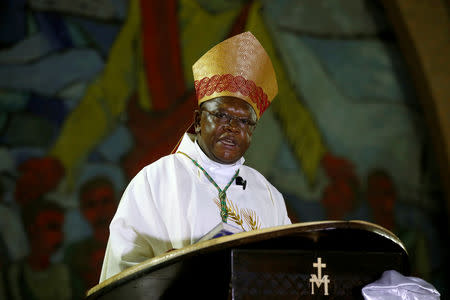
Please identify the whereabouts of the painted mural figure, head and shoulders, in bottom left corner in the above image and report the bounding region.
[6,199,72,300]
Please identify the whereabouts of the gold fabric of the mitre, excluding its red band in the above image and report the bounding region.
[192,31,278,119]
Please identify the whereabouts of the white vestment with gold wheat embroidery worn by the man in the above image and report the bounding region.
[100,134,291,282]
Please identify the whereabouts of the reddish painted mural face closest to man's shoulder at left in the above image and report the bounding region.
[80,181,117,243]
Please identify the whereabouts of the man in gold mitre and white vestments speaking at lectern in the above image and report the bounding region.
[100,32,290,281]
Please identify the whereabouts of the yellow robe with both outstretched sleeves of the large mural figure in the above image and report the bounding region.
[50,0,325,185]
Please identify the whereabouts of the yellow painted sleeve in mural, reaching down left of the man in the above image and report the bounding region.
[50,0,150,186]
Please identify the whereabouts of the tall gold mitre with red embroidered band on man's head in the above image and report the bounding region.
[192,31,278,119]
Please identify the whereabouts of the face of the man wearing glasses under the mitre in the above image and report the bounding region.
[195,96,257,164]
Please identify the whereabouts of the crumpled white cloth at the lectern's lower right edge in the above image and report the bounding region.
[362,270,440,300]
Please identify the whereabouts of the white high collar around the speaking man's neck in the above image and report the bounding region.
[178,134,245,184]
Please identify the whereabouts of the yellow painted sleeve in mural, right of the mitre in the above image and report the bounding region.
[247,1,326,184]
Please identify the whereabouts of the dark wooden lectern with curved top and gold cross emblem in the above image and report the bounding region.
[87,221,409,300]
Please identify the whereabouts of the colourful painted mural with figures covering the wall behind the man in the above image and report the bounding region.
[0,0,449,299]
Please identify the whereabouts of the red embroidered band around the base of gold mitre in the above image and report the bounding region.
[194,74,270,115]
